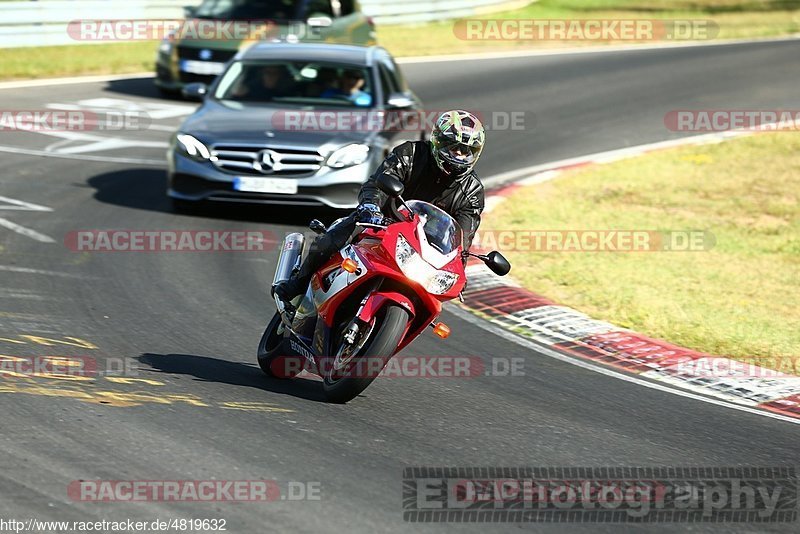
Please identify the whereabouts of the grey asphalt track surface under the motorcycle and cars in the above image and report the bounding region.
[0,42,800,532]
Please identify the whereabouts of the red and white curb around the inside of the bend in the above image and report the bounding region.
[464,131,800,419]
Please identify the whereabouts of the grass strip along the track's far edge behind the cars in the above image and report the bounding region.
[0,0,800,80]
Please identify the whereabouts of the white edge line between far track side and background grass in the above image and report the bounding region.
[396,34,800,65]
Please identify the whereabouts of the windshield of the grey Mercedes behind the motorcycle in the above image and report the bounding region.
[214,61,374,108]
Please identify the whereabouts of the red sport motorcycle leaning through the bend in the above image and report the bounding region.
[258,176,511,403]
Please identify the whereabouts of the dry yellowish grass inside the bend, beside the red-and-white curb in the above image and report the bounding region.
[481,132,800,372]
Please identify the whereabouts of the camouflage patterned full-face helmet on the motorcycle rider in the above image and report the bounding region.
[431,110,486,177]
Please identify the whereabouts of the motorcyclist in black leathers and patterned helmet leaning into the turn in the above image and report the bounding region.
[272,110,486,307]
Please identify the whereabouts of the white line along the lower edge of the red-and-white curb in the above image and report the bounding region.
[446,303,800,425]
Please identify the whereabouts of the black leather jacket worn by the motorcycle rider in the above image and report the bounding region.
[358,141,483,250]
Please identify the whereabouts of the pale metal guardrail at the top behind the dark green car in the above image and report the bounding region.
[0,0,530,48]
